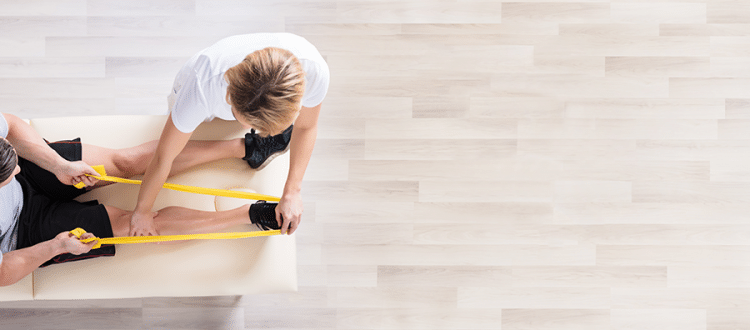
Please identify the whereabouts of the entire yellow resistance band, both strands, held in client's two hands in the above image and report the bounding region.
[70,165,281,249]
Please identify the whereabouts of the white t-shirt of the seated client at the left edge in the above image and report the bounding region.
[0,114,23,263]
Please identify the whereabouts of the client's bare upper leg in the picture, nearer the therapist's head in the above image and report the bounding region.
[82,138,245,186]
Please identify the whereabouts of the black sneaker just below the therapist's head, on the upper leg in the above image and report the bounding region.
[242,125,294,171]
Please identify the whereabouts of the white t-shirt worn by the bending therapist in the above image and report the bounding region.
[168,33,330,133]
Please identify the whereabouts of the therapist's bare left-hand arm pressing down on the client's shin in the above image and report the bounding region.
[129,114,193,236]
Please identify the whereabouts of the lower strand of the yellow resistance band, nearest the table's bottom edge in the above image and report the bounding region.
[70,228,281,249]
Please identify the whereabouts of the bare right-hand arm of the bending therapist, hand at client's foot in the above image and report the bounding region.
[276,104,322,234]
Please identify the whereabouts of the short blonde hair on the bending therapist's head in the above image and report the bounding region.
[224,47,305,134]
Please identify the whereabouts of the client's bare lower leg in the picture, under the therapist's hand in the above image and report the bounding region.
[105,204,250,237]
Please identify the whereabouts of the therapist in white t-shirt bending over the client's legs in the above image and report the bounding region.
[130,33,330,236]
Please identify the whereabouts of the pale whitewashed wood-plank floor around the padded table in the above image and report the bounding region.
[0,0,750,330]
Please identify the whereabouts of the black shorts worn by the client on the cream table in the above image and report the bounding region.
[16,139,115,266]
